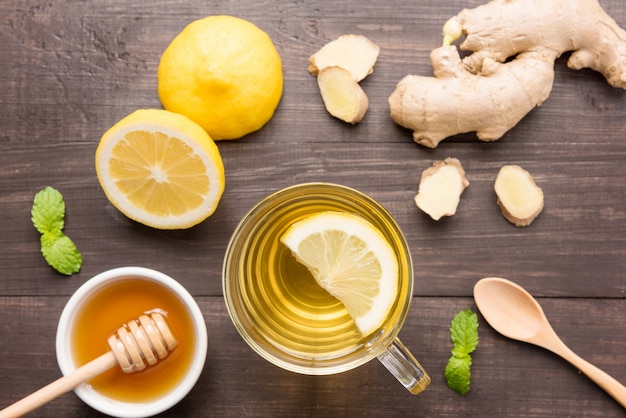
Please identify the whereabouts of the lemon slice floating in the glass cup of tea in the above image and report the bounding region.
[281,211,399,335]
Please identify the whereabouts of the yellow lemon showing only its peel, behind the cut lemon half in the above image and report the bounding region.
[158,15,283,140]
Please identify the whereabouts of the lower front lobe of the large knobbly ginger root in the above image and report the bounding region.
[389,46,554,148]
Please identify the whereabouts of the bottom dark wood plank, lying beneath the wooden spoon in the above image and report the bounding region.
[0,297,626,417]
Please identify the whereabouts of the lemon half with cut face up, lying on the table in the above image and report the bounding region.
[96,109,225,229]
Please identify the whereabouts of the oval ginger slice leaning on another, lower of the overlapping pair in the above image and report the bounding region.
[317,67,369,124]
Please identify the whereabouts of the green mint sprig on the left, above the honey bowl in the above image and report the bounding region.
[30,186,83,276]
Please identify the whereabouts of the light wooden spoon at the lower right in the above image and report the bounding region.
[474,277,626,408]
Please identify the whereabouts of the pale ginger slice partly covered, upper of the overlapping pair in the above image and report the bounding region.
[308,34,380,82]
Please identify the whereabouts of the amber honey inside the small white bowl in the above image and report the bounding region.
[71,277,196,403]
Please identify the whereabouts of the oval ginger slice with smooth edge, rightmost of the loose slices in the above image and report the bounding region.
[494,165,543,227]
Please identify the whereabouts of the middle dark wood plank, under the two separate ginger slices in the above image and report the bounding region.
[0,138,626,297]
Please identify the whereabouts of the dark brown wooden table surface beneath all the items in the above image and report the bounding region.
[0,0,626,417]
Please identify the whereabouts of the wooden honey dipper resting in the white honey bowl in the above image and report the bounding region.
[0,311,178,418]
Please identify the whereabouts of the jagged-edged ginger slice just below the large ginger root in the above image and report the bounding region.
[415,158,469,221]
